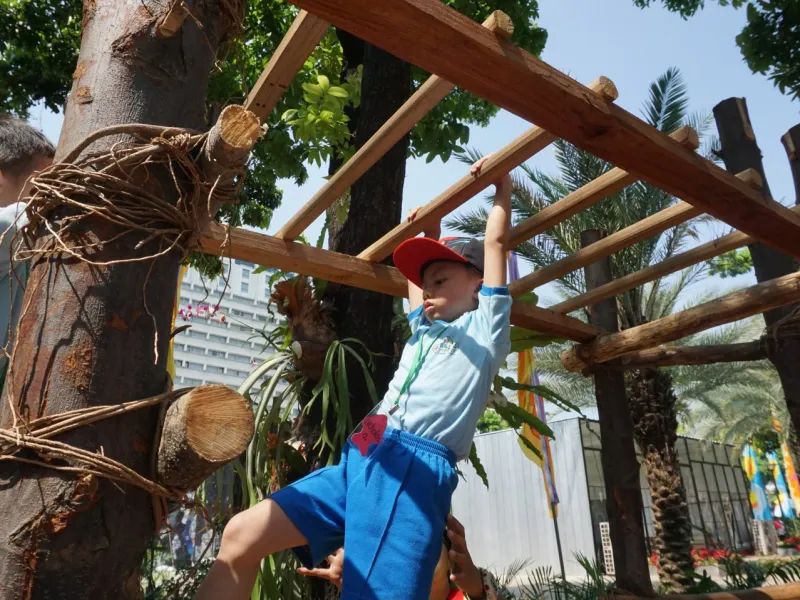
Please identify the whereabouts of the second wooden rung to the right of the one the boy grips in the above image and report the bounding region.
[509,202,701,296]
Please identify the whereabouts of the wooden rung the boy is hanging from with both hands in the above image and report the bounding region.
[358,77,617,261]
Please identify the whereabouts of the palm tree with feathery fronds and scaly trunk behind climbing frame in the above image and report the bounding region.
[447,68,713,591]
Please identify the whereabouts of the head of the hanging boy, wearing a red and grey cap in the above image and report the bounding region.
[394,238,483,321]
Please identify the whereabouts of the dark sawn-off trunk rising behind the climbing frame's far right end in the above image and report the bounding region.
[714,98,800,440]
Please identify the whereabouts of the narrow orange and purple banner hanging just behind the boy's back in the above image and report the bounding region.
[508,252,559,517]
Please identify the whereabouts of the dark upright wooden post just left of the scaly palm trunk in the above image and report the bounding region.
[581,229,653,596]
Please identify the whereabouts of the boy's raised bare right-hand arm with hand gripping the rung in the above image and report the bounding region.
[471,154,511,287]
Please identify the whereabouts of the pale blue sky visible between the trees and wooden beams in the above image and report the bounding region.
[31,0,800,304]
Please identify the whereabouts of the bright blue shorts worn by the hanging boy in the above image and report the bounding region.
[270,427,458,600]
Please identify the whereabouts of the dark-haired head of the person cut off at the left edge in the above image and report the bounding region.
[0,115,56,207]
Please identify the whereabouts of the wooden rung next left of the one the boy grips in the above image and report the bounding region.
[276,10,514,240]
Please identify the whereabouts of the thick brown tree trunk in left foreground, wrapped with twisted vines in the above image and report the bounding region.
[0,0,241,600]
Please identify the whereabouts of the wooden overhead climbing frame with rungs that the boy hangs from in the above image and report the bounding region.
[202,0,800,370]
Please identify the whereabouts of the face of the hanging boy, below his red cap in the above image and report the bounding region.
[422,261,481,322]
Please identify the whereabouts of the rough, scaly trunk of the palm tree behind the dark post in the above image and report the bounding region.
[628,369,693,592]
